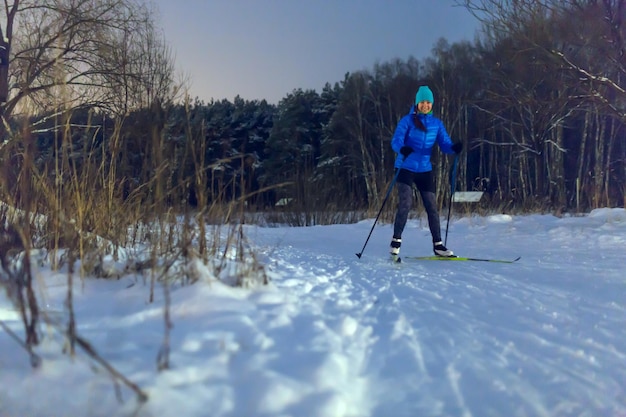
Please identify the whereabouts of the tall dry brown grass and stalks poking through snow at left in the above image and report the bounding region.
[0,105,269,403]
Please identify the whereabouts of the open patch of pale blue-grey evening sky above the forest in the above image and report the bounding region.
[153,0,479,103]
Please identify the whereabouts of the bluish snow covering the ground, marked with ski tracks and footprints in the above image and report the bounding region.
[0,208,626,417]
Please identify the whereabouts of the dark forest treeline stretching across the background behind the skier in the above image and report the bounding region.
[0,0,626,228]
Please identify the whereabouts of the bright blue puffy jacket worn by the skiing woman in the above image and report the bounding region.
[391,106,454,172]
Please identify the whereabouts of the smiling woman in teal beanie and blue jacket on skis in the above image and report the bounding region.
[391,86,463,261]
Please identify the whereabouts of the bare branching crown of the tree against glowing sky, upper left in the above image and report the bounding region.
[0,0,178,140]
